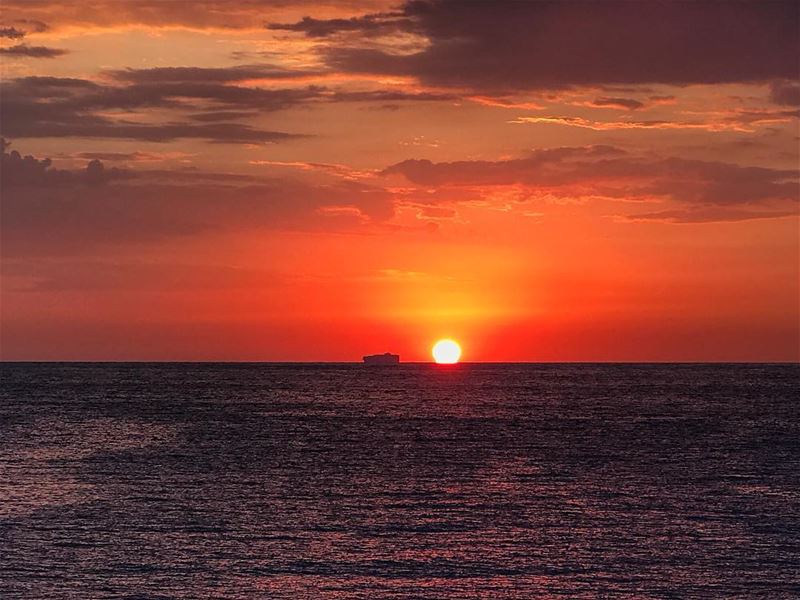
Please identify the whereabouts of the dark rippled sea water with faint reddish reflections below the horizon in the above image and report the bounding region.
[0,364,800,599]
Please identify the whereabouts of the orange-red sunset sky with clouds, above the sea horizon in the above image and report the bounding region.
[0,0,800,361]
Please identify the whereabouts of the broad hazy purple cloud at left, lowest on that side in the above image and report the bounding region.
[0,146,394,256]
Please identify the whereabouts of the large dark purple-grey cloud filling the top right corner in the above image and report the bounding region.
[316,0,800,91]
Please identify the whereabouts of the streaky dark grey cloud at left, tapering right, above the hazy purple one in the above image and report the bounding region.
[0,68,456,143]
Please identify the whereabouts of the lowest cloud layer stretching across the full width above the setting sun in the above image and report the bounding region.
[0,141,800,256]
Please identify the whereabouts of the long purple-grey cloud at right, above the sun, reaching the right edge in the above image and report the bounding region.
[384,147,800,210]
